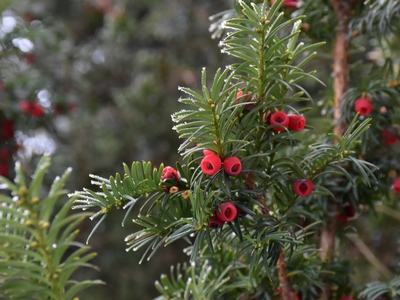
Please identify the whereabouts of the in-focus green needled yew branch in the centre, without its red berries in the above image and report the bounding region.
[71,1,391,299]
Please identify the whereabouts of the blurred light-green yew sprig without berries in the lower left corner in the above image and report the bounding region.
[0,156,102,300]
